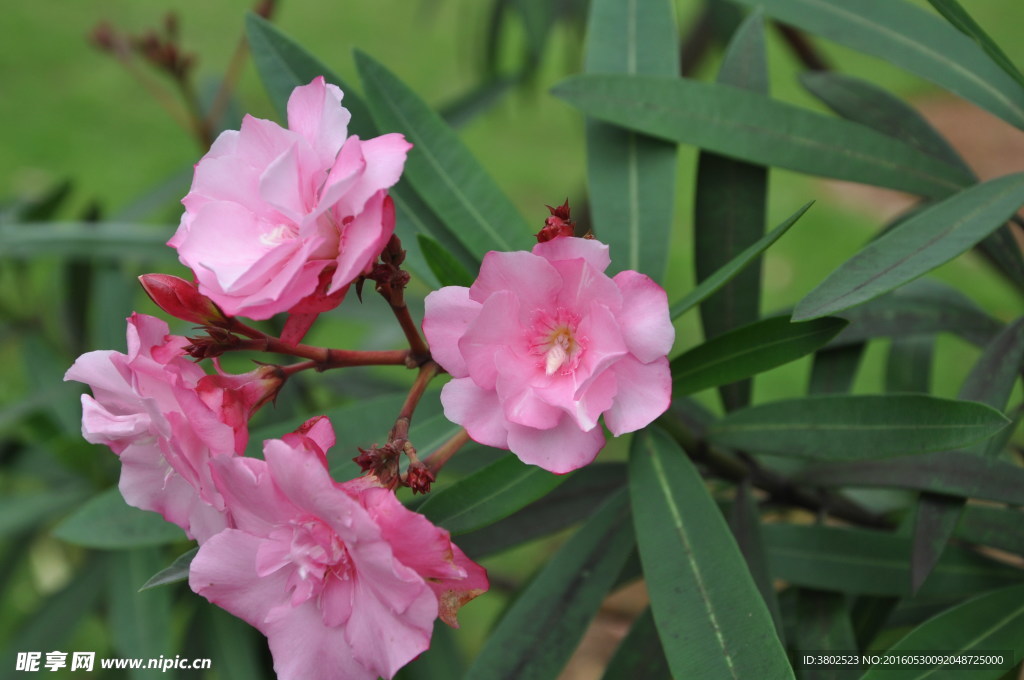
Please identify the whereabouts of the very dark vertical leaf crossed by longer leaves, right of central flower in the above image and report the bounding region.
[693,10,768,411]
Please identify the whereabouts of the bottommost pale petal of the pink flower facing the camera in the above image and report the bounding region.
[509,416,604,474]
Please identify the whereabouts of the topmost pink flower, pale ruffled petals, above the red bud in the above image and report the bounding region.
[168,77,412,337]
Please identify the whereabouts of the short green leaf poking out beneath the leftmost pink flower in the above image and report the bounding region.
[53,487,185,550]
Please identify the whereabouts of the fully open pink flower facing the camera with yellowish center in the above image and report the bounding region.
[423,237,675,473]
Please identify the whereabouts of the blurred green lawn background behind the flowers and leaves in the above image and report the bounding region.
[6,0,1024,678]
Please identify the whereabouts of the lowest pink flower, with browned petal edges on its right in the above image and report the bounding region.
[188,417,487,680]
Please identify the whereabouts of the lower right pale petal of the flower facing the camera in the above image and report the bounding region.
[604,356,672,436]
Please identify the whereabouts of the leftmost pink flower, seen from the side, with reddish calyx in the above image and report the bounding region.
[65,313,282,541]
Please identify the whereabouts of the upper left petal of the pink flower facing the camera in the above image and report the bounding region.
[469,251,562,311]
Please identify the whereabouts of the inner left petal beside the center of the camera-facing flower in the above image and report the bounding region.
[459,290,536,389]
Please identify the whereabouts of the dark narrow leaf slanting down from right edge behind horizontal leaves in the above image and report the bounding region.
[911,318,1024,590]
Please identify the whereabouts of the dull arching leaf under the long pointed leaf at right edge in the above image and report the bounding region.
[829,280,1002,347]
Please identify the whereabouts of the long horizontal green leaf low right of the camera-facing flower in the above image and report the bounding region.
[709,394,1010,461]
